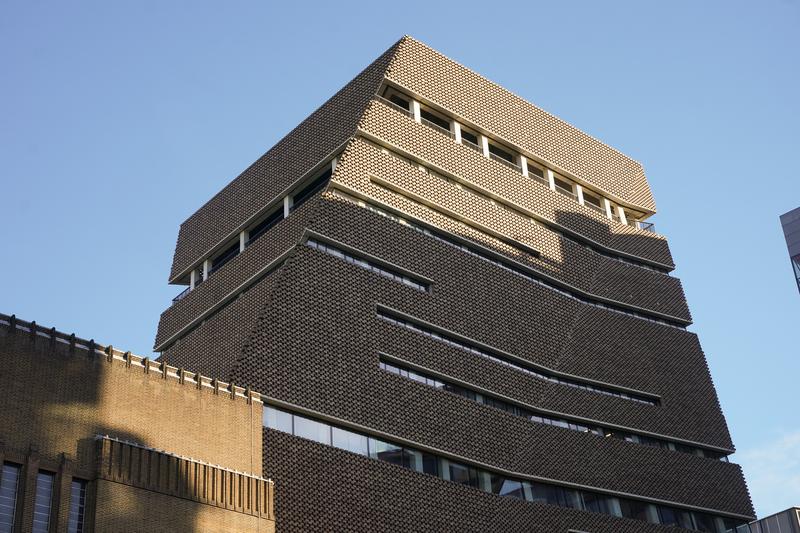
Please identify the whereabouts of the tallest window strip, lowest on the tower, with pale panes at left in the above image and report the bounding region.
[264,405,741,533]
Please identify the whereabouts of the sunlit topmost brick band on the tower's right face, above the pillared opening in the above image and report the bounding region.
[386,37,655,211]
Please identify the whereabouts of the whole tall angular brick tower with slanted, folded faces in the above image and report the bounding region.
[155,37,753,533]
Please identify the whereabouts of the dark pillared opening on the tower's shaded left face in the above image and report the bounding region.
[172,164,334,304]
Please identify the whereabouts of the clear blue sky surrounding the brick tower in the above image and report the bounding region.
[0,0,800,515]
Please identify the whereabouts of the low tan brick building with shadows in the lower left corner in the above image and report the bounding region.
[0,315,275,533]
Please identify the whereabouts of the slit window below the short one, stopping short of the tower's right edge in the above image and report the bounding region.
[377,308,658,405]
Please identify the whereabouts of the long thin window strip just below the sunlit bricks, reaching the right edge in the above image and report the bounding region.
[335,187,686,330]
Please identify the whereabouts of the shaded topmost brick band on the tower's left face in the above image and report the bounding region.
[170,43,394,279]
